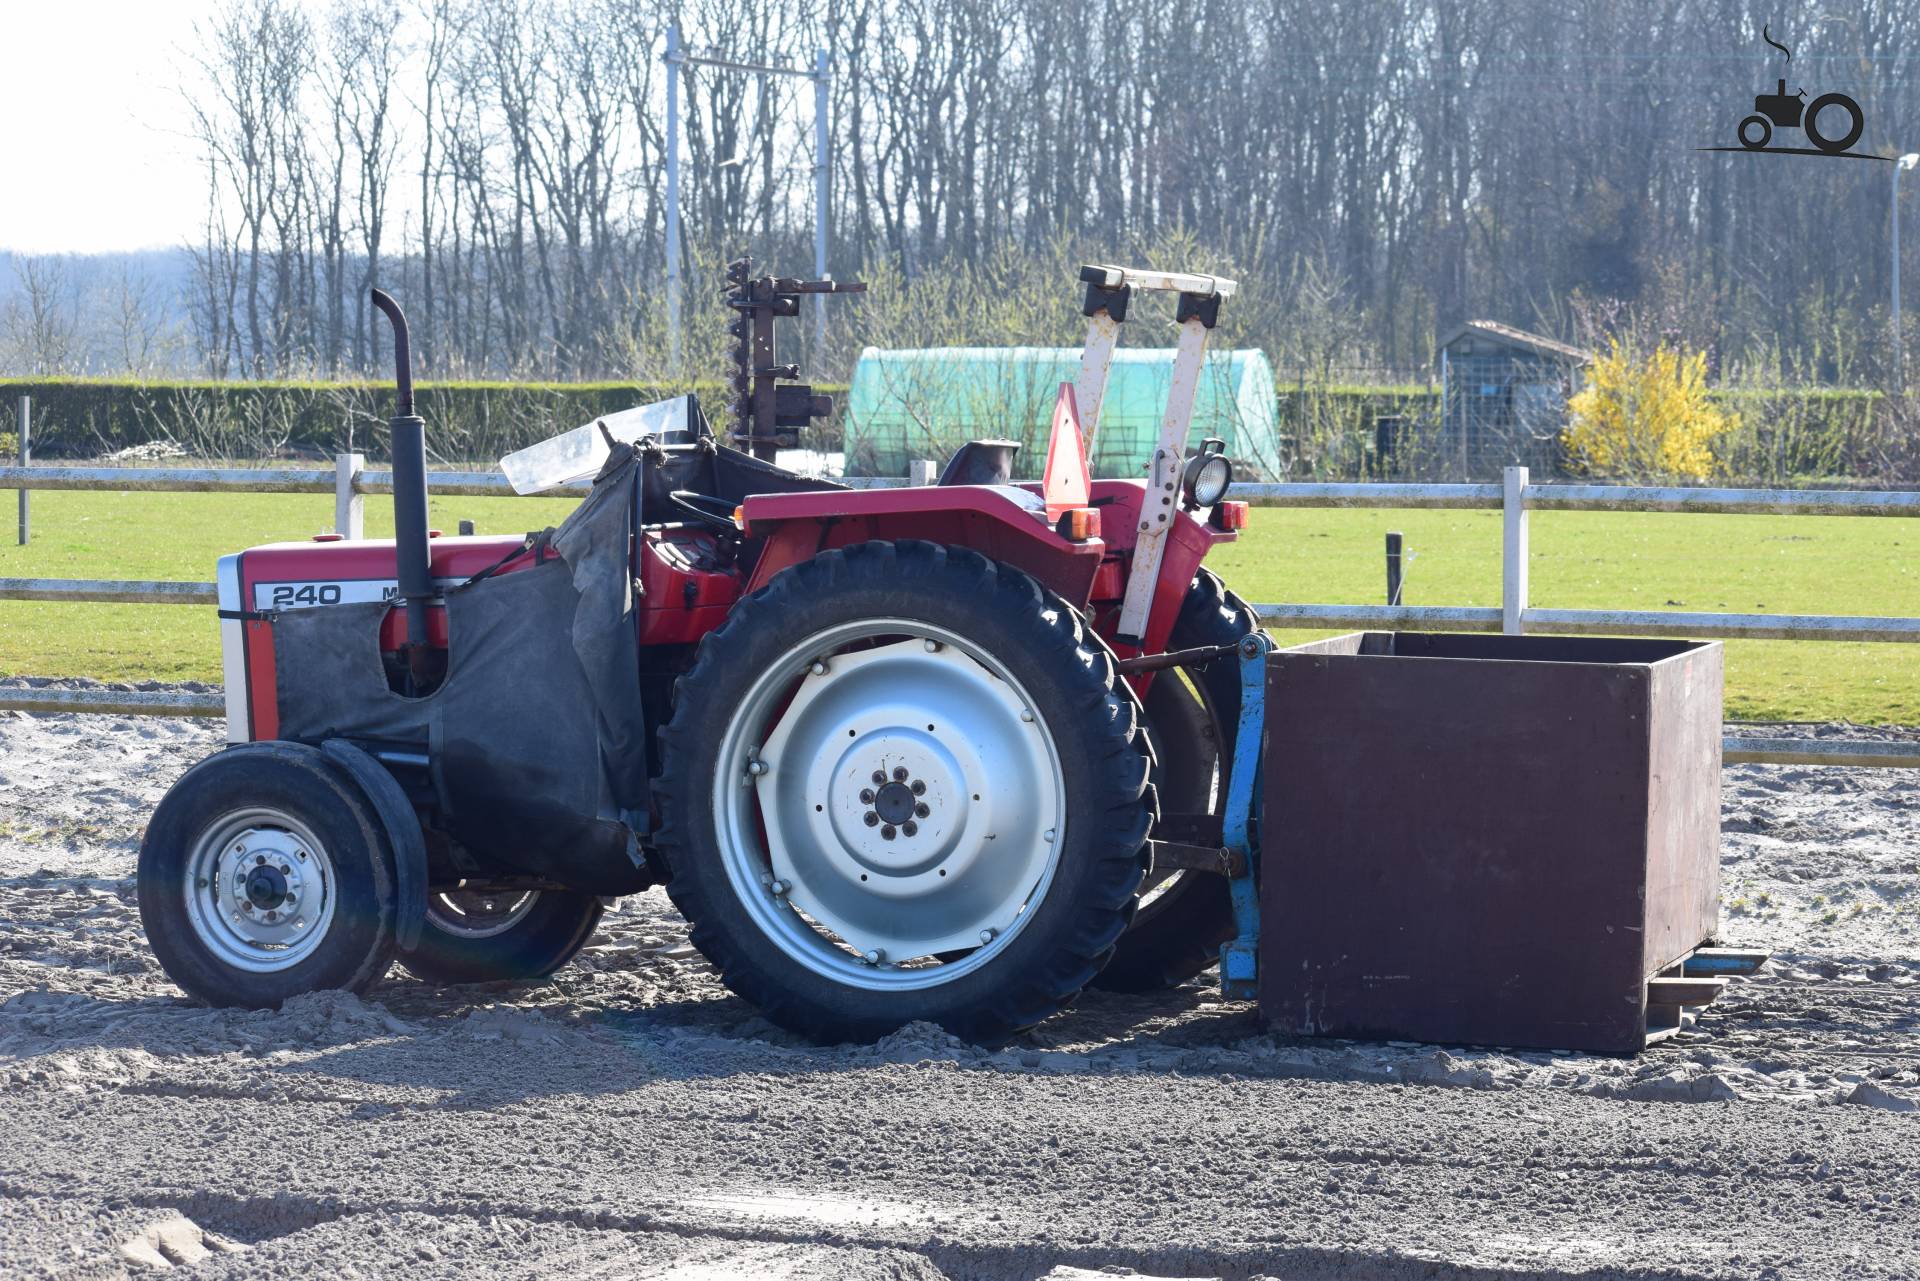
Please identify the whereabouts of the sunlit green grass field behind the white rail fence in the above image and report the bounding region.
[0,494,1920,724]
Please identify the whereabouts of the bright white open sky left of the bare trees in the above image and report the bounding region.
[0,0,209,254]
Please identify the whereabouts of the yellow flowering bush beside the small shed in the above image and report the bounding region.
[1563,340,1740,480]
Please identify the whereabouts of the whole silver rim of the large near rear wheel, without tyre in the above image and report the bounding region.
[712,618,1066,991]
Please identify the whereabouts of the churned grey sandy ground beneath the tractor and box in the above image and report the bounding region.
[0,691,1920,1281]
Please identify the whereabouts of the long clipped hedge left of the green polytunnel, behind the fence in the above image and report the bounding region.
[0,378,845,461]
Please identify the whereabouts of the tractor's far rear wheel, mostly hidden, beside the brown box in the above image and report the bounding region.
[1094,570,1260,991]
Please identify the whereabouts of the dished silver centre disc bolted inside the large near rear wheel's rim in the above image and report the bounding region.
[724,628,1064,974]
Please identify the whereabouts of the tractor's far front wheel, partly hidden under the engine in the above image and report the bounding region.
[399,889,601,983]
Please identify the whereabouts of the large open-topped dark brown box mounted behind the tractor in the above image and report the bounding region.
[1260,632,1722,1054]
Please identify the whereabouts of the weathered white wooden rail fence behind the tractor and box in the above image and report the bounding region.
[0,453,1920,766]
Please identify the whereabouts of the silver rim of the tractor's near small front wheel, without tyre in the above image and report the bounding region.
[182,807,338,974]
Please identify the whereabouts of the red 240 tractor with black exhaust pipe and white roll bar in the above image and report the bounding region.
[138,265,1258,1043]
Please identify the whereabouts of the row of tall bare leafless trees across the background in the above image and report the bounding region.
[131,0,1920,380]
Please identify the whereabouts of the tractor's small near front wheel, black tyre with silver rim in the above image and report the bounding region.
[138,741,397,1008]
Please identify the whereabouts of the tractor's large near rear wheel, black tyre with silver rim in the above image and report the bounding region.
[655,542,1152,1043]
